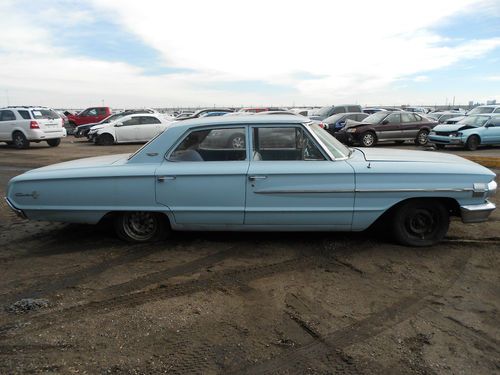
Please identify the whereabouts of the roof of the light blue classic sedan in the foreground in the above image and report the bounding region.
[170,115,310,128]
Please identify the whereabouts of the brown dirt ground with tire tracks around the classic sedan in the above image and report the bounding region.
[0,137,500,374]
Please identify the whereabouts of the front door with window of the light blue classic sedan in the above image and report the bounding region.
[245,125,354,229]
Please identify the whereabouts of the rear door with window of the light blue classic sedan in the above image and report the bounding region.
[156,126,249,227]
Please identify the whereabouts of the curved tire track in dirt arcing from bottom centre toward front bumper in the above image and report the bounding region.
[231,247,471,375]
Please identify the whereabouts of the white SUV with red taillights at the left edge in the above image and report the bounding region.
[0,107,66,148]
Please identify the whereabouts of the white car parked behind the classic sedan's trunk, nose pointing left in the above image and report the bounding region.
[87,113,172,145]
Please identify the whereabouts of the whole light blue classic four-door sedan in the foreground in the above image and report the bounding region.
[3,116,496,246]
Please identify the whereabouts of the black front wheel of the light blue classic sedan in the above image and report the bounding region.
[391,199,450,247]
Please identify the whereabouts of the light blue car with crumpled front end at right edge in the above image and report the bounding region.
[429,113,500,151]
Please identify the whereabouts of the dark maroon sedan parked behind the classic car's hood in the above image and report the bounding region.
[335,111,438,147]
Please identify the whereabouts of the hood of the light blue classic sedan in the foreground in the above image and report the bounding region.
[357,148,472,164]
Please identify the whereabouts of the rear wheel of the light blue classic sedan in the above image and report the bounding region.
[114,211,170,243]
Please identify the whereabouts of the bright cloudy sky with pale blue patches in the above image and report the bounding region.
[0,0,500,108]
